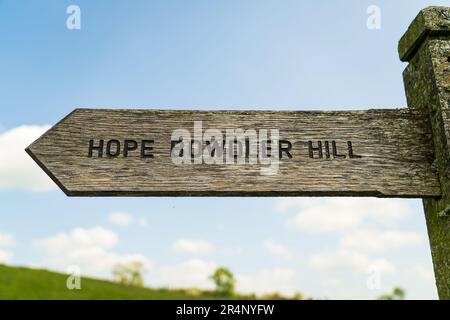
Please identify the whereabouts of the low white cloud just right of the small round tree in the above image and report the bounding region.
[236,268,299,295]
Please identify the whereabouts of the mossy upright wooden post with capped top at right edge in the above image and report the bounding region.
[398,7,450,299]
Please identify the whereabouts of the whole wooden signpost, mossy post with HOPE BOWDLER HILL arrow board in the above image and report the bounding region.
[26,7,450,299]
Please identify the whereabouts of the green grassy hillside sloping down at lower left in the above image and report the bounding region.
[0,265,232,300]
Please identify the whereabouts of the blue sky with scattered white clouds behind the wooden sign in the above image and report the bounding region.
[0,0,448,298]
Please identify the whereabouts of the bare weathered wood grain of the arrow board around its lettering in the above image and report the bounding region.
[27,109,441,197]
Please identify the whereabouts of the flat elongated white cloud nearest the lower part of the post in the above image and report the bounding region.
[340,229,423,252]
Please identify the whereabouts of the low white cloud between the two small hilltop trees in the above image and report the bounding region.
[150,259,217,289]
